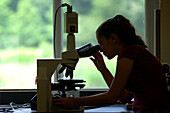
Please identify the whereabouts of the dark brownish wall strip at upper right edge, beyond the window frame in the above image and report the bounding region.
[160,0,170,65]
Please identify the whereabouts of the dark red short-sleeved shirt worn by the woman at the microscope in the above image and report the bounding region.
[118,45,169,112]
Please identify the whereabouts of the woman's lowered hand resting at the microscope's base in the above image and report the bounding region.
[53,97,79,109]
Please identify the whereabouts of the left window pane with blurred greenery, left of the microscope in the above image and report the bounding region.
[0,0,53,89]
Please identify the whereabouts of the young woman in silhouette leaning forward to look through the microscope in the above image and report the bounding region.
[54,15,169,113]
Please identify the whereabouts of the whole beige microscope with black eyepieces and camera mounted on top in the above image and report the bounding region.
[36,4,100,112]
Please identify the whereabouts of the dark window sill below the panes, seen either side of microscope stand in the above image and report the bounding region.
[0,87,108,104]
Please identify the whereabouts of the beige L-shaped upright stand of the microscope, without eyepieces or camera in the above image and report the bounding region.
[37,59,74,112]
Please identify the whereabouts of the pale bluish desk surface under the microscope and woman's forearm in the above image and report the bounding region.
[0,104,133,113]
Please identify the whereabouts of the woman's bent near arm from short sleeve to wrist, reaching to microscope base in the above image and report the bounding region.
[76,58,133,106]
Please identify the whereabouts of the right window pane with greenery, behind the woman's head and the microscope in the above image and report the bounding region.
[63,0,145,87]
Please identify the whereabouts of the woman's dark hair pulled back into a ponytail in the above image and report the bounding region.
[96,15,147,48]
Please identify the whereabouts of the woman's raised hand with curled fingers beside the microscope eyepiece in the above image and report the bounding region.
[90,52,106,72]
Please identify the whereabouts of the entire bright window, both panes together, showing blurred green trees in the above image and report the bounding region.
[0,0,145,89]
